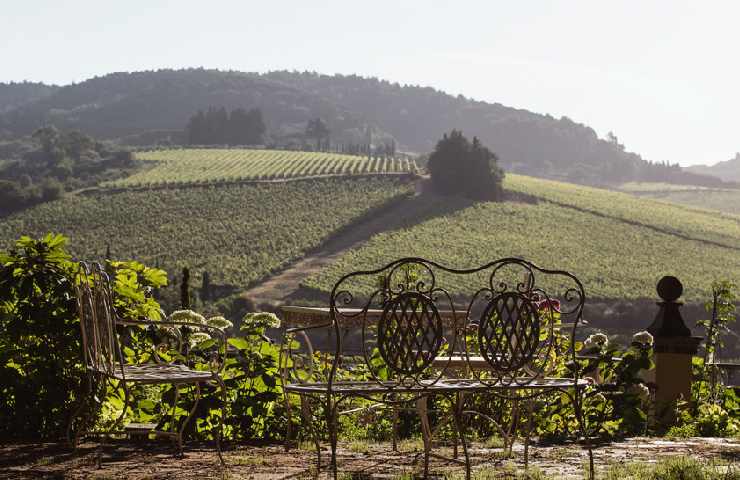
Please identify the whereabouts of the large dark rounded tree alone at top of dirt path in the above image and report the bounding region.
[427,130,504,200]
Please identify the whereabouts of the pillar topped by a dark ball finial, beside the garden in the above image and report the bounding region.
[647,276,702,424]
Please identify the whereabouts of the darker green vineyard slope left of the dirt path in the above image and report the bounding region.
[0,177,408,287]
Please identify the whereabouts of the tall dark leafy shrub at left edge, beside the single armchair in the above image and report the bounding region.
[0,234,83,438]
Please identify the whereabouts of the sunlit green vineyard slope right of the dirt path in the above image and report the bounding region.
[306,175,740,300]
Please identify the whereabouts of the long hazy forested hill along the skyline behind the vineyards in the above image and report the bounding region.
[0,69,717,184]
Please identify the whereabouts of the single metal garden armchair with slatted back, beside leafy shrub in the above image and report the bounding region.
[67,262,226,463]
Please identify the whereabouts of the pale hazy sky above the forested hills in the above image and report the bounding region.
[0,0,740,165]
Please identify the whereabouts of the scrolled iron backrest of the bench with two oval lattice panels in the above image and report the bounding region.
[329,258,585,390]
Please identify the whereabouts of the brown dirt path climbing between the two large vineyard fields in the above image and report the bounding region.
[245,191,434,304]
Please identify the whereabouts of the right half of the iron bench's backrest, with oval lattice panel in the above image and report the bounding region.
[465,258,585,387]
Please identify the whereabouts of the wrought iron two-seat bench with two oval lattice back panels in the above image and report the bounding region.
[284,258,588,478]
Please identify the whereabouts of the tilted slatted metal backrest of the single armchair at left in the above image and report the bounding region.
[76,262,122,375]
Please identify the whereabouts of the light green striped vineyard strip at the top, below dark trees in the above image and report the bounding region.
[104,149,416,188]
